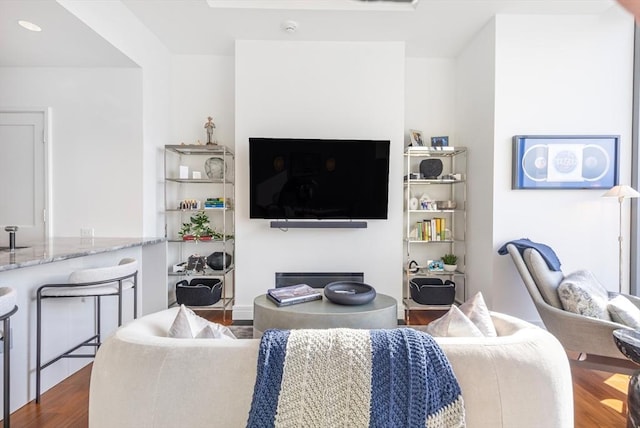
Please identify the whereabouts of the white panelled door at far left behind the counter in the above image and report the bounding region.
[0,110,47,246]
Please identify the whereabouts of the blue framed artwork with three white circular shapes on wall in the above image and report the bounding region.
[512,135,620,189]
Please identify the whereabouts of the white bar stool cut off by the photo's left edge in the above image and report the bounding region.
[0,287,18,428]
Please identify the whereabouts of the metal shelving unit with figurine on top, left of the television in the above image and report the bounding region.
[164,145,235,317]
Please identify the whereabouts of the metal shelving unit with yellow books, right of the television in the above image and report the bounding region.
[403,146,467,311]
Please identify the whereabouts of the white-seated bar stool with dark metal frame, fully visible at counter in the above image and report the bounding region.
[36,258,138,403]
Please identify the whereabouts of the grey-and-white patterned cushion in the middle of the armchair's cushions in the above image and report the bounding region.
[558,270,611,321]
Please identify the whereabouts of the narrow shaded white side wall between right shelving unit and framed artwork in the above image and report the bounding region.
[455,19,496,307]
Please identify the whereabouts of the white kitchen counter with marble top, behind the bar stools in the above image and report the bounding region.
[0,237,168,411]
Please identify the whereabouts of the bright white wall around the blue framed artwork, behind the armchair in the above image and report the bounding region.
[492,8,633,319]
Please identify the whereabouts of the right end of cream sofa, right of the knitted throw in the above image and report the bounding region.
[436,313,574,428]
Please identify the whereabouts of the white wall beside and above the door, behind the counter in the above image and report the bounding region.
[0,68,142,236]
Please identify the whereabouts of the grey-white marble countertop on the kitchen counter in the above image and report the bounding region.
[0,238,166,272]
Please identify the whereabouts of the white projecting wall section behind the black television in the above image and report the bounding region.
[233,41,405,319]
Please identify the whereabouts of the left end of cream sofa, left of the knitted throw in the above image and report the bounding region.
[89,309,260,428]
